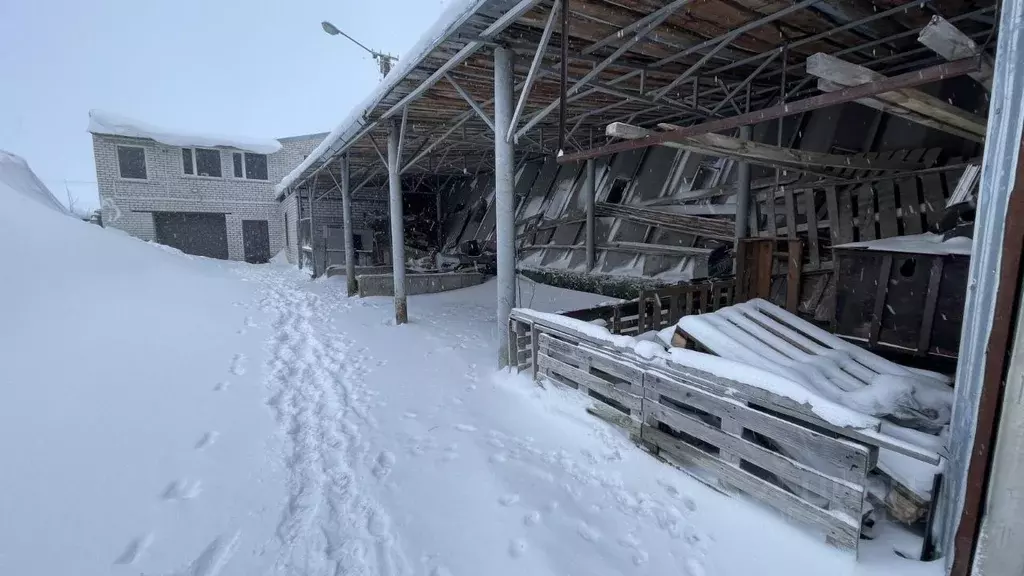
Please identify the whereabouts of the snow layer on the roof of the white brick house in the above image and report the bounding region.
[89,110,281,154]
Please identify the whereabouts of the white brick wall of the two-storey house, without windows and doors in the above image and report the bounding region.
[92,134,324,261]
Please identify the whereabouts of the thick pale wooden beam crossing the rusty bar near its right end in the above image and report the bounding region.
[807,52,986,137]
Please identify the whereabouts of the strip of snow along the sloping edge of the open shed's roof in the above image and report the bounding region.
[274,0,488,198]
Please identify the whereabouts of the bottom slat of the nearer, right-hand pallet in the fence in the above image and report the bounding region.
[640,424,860,550]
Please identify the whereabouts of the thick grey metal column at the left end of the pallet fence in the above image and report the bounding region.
[495,46,515,368]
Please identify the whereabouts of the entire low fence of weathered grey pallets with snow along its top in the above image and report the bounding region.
[509,308,878,551]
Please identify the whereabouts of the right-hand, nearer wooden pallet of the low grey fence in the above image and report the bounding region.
[640,368,870,550]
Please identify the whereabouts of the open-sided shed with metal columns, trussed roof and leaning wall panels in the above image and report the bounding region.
[278,0,1022,574]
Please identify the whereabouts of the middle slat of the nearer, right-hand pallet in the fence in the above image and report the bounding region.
[643,402,864,519]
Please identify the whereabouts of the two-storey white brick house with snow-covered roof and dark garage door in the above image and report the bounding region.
[89,111,325,261]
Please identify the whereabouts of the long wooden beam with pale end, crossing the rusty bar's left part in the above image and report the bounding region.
[605,122,922,172]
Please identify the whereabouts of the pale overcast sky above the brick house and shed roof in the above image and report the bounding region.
[0,0,445,211]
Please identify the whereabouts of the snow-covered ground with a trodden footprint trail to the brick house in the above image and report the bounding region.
[0,168,941,576]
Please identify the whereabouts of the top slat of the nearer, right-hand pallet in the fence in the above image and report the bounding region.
[644,374,868,478]
